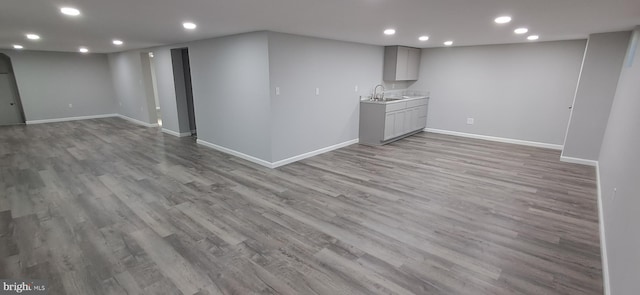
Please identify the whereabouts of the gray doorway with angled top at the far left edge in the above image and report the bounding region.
[0,53,25,126]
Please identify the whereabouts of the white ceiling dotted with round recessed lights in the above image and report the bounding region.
[0,0,640,52]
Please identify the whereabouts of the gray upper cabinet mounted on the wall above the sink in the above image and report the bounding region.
[383,46,421,81]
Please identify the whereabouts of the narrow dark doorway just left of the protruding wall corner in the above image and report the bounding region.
[171,48,197,137]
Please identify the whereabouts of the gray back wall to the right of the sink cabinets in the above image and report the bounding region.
[410,40,586,145]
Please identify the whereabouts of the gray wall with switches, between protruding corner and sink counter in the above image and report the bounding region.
[266,33,383,162]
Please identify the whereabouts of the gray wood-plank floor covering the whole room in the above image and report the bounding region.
[0,118,602,295]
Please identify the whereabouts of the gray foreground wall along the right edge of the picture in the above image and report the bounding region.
[599,27,640,295]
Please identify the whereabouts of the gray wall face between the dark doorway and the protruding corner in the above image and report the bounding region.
[188,32,271,161]
